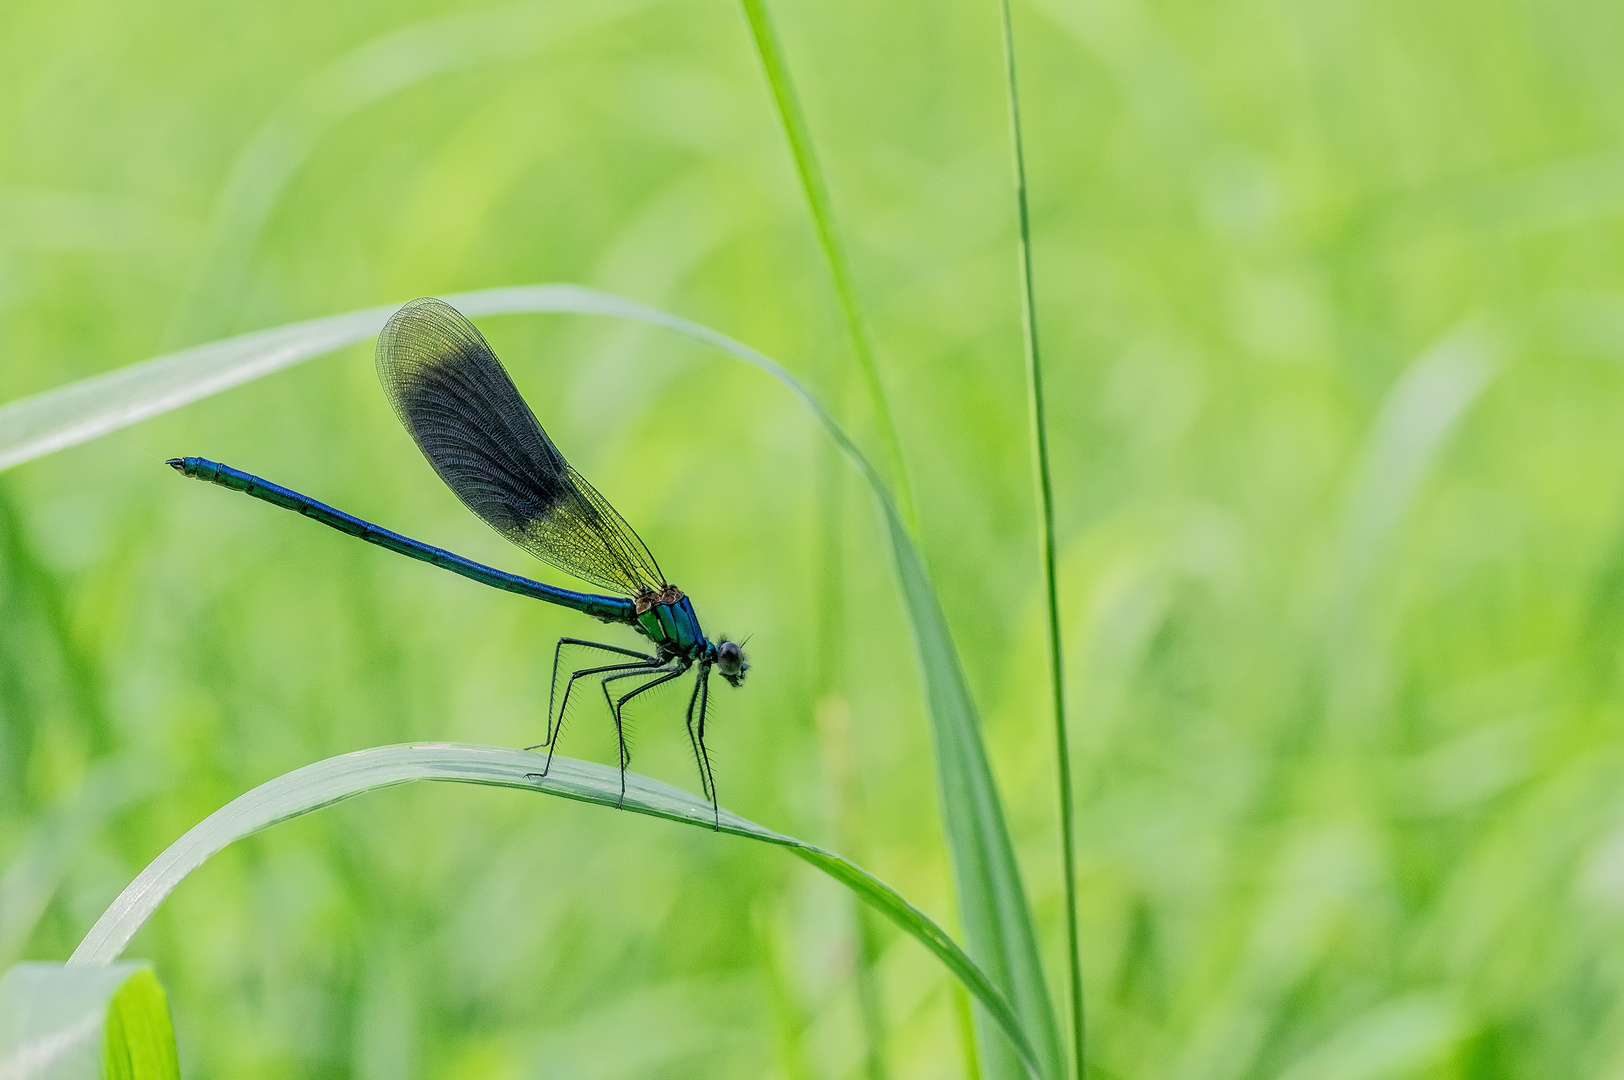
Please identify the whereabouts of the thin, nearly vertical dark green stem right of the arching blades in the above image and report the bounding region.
[999,0,1083,1080]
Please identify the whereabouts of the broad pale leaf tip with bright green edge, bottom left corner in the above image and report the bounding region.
[0,963,180,1080]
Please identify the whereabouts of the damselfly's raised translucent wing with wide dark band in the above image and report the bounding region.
[377,297,666,596]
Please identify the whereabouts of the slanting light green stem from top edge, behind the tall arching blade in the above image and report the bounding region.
[741,0,919,534]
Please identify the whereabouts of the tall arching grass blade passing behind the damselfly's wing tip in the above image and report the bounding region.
[0,284,1062,1077]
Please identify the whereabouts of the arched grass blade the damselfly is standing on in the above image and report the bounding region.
[68,744,1038,1075]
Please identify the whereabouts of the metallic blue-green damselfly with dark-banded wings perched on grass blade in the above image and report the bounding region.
[169,297,750,828]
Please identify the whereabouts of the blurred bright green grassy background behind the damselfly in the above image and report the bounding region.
[0,0,1624,1080]
